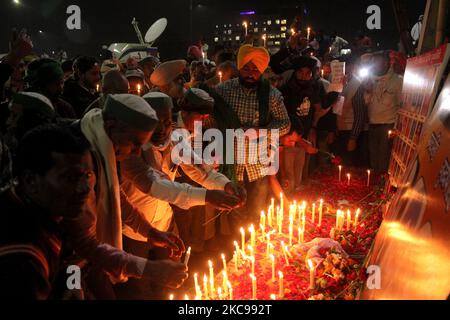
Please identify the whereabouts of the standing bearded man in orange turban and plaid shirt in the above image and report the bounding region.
[216,45,290,222]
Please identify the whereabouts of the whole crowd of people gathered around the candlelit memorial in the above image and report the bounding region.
[0,25,405,299]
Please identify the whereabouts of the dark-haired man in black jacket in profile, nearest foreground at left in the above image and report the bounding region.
[0,125,95,300]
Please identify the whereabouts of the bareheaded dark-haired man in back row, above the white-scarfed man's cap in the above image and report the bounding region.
[63,56,100,119]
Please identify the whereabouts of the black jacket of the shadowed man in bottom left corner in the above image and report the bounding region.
[0,190,61,300]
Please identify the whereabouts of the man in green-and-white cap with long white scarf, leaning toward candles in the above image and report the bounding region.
[67,94,187,298]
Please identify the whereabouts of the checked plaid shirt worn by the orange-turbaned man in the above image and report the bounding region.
[216,78,290,182]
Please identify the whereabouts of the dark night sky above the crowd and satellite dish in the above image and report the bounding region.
[0,0,425,58]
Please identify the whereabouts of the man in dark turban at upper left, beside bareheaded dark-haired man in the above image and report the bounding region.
[25,59,76,119]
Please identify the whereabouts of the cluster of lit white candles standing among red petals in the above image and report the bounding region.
[170,194,361,300]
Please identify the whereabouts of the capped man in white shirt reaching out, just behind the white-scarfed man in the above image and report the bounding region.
[117,92,243,298]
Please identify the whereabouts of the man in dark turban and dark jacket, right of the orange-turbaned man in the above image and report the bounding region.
[280,56,330,191]
